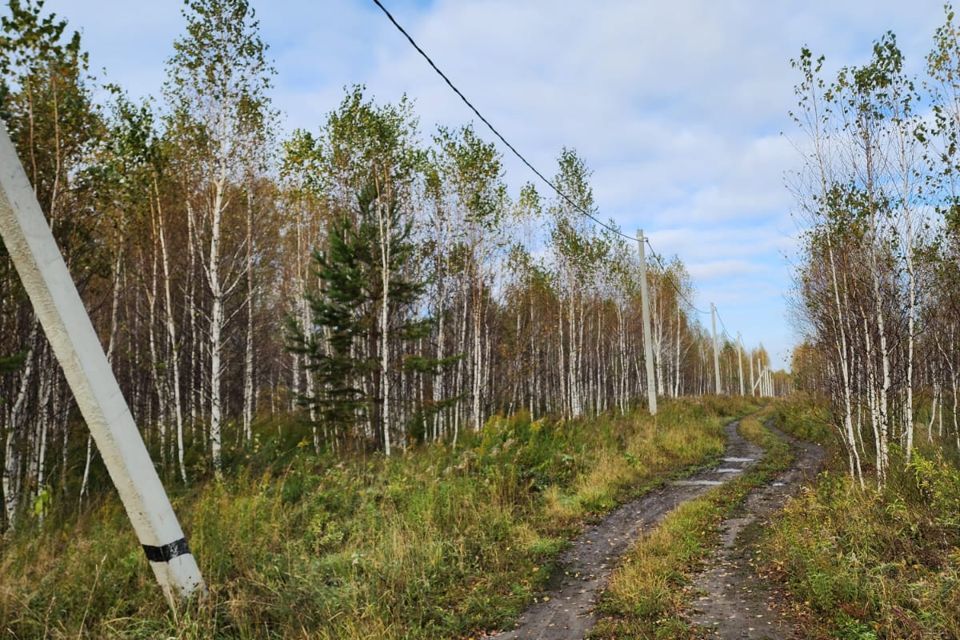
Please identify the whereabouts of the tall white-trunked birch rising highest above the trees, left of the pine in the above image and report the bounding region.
[164,0,273,473]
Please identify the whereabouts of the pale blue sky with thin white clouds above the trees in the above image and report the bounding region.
[35,0,943,366]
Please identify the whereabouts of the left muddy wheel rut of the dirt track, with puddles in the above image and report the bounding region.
[485,421,763,640]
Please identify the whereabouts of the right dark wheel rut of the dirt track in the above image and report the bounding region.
[690,425,824,640]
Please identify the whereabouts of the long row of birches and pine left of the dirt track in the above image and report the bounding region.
[0,0,768,529]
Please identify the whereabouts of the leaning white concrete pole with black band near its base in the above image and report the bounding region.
[0,126,204,607]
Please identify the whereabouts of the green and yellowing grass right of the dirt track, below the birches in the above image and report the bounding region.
[762,404,960,640]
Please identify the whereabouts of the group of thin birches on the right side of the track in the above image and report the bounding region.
[793,6,960,484]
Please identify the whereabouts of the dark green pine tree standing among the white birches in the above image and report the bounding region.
[289,175,434,450]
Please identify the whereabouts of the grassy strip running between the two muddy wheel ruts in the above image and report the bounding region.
[591,416,793,640]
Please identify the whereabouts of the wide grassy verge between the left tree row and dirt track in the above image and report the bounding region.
[0,399,749,639]
